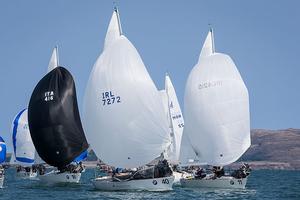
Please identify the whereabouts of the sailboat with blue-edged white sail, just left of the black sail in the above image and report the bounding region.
[10,109,37,179]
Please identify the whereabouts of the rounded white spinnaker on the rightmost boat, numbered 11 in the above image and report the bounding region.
[184,53,250,165]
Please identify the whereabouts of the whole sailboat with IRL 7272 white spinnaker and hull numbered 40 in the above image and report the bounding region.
[83,8,174,191]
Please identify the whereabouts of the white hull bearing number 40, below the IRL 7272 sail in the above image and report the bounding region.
[93,176,174,191]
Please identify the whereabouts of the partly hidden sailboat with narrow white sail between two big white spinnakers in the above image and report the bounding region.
[160,74,184,183]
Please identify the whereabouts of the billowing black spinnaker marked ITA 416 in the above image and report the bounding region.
[28,67,88,169]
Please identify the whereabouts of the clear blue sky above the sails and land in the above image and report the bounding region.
[0,0,300,151]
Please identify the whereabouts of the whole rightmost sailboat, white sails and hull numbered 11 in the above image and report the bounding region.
[180,29,251,188]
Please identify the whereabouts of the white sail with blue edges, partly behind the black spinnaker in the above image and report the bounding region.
[12,109,35,166]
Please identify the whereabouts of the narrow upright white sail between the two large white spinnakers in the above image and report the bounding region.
[165,75,184,162]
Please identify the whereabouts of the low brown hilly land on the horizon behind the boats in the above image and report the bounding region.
[7,128,300,170]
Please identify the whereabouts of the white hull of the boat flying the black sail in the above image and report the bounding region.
[38,171,81,184]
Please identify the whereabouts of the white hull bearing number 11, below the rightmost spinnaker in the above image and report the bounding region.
[180,176,247,189]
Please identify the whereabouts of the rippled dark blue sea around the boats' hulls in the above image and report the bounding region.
[0,169,300,200]
